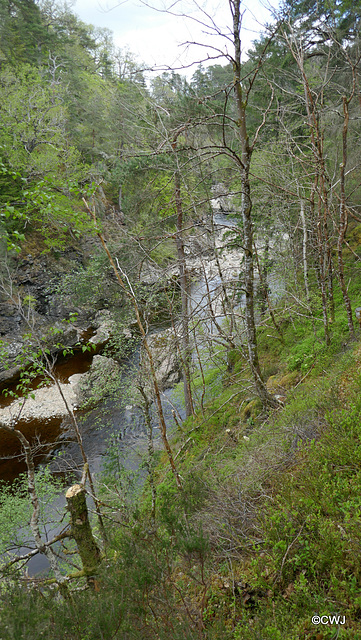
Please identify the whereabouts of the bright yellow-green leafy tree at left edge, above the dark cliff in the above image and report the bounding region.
[0,65,95,251]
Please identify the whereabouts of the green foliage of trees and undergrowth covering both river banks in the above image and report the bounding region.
[0,0,361,640]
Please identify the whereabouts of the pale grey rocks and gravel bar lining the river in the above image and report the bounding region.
[0,210,240,480]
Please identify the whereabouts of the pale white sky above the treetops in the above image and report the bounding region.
[73,0,271,75]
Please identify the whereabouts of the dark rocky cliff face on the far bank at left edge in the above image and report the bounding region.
[0,238,94,383]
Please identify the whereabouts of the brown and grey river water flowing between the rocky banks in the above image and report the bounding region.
[0,213,242,575]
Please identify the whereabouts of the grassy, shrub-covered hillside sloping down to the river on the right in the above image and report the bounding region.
[0,248,361,640]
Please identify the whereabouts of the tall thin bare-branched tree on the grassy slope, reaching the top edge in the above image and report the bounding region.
[139,0,277,406]
